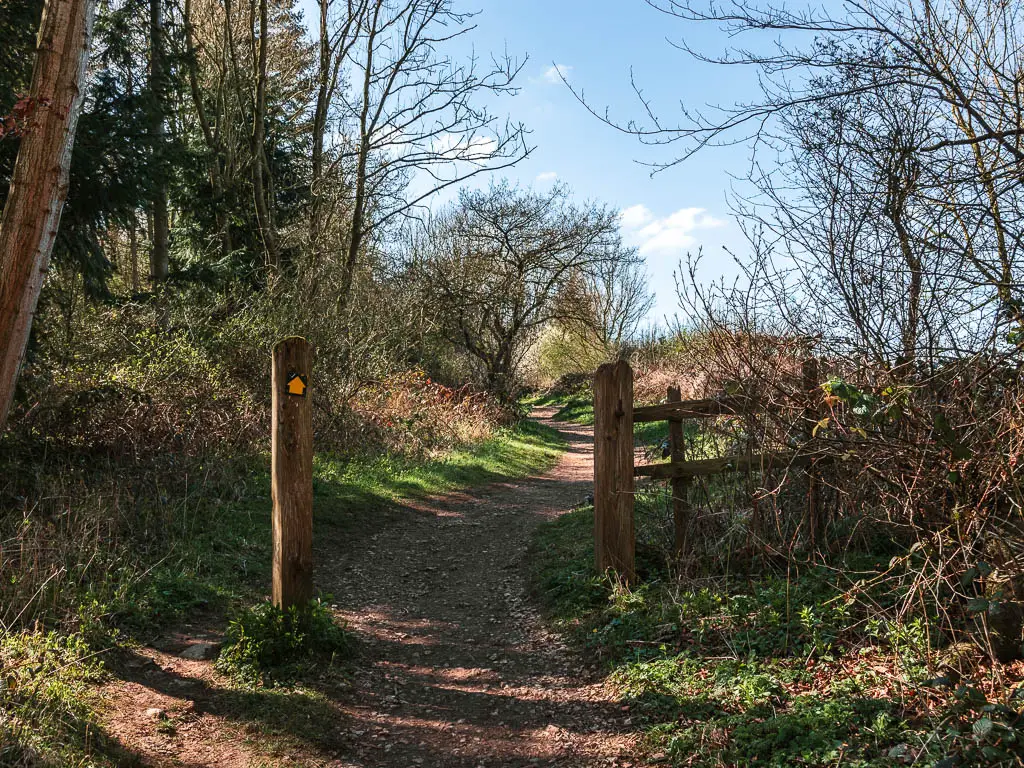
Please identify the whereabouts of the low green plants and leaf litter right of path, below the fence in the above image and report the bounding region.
[530,498,1024,768]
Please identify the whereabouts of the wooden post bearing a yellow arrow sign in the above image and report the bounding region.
[270,337,313,608]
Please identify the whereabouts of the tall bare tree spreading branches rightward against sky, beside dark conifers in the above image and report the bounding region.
[334,0,530,303]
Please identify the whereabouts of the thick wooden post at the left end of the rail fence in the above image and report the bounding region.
[594,360,635,582]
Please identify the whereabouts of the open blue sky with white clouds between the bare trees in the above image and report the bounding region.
[301,0,756,323]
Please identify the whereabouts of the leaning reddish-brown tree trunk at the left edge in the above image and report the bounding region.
[0,0,96,429]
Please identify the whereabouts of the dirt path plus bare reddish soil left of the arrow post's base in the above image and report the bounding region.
[96,409,637,768]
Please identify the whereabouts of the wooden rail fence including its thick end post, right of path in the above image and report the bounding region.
[594,358,831,582]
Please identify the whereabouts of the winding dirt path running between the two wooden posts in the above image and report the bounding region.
[322,410,633,768]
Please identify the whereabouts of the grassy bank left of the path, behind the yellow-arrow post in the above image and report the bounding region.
[0,422,562,766]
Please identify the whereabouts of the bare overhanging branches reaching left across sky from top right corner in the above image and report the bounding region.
[578,0,1024,169]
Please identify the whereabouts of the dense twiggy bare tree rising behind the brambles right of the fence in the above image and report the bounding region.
[736,73,958,365]
